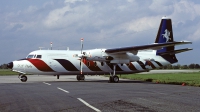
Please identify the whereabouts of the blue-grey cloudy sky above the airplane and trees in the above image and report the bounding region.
[0,0,200,64]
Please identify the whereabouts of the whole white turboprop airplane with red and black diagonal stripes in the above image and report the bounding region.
[7,17,192,82]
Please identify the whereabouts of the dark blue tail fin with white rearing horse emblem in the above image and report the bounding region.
[155,17,178,63]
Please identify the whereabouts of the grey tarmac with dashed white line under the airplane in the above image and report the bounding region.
[0,71,200,112]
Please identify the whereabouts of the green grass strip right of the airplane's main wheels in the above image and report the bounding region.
[120,72,200,87]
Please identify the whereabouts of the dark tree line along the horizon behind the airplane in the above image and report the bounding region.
[0,63,200,69]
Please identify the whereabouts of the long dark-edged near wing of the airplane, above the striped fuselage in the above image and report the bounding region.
[105,41,192,53]
